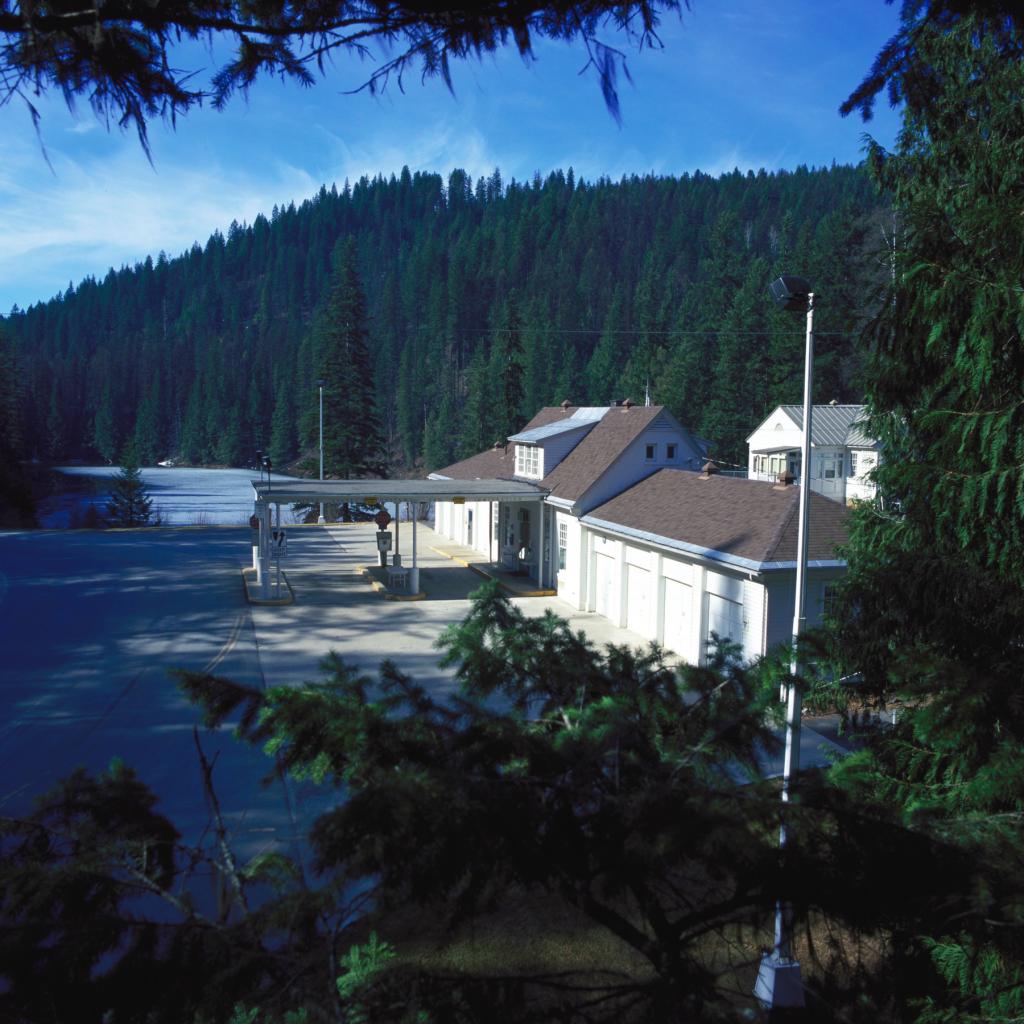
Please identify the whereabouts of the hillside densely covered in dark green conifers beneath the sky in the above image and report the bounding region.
[6,167,888,469]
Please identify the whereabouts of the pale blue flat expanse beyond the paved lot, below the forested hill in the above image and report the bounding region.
[39,466,303,528]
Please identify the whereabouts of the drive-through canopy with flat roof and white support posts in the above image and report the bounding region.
[252,480,549,593]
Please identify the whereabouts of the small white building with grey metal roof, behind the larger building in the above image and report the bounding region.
[746,404,880,503]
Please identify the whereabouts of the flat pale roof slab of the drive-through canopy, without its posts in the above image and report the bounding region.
[251,478,549,505]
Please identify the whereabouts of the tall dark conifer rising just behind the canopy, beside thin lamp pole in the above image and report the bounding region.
[312,238,384,479]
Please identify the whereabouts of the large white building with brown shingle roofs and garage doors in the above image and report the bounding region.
[431,404,847,664]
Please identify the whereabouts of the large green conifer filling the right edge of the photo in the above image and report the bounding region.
[834,12,1024,1022]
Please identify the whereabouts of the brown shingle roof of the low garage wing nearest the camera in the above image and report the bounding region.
[584,469,849,562]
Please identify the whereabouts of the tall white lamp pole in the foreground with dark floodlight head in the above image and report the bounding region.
[754,274,814,1010]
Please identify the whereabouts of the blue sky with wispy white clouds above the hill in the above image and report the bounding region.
[0,0,897,311]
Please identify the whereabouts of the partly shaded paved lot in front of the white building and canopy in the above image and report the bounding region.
[0,524,843,854]
